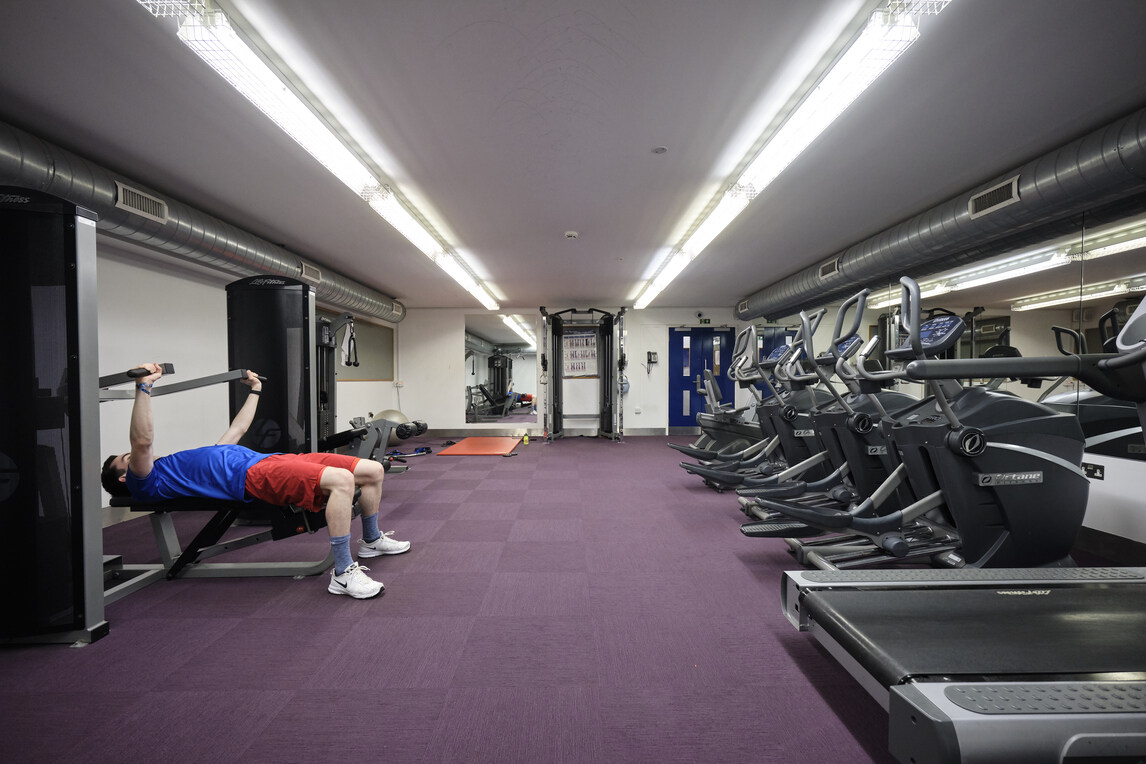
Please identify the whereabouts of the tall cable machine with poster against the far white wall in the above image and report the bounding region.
[540,307,627,441]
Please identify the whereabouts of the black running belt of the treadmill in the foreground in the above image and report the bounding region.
[802,583,1146,687]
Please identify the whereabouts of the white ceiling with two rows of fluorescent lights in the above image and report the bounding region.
[0,0,1146,343]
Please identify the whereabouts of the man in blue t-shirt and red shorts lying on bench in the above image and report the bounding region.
[101,363,410,599]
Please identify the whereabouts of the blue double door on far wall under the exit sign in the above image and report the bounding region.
[668,326,735,427]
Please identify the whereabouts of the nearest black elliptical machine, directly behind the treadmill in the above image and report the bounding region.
[762,278,1090,567]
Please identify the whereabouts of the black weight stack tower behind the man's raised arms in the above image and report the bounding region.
[227,276,319,454]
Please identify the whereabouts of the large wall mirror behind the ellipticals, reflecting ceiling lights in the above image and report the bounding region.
[865,207,1146,459]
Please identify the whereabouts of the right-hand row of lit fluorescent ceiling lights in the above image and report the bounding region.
[634,0,949,308]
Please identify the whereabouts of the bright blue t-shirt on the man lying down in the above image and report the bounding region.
[126,446,270,502]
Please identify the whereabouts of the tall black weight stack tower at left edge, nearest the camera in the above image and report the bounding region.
[0,187,108,643]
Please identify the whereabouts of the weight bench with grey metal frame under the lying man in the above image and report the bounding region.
[104,496,359,604]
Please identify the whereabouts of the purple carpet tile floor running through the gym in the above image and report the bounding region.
[0,438,892,764]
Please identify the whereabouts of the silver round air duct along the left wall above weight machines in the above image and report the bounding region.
[0,121,406,323]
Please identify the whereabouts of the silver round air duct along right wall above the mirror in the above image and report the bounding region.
[736,109,1146,321]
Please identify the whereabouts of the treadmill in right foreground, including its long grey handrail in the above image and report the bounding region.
[782,282,1146,764]
